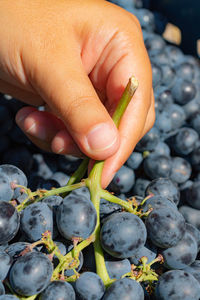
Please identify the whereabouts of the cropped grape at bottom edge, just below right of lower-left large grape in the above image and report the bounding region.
[40,280,76,300]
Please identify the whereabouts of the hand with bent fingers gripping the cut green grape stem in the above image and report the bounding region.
[0,0,155,187]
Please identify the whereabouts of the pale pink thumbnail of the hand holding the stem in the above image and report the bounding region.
[86,123,118,152]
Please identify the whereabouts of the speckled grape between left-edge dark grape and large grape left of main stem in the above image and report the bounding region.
[20,202,53,241]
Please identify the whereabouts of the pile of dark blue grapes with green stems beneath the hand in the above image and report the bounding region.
[0,0,200,300]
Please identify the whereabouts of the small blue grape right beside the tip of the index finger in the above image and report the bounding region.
[112,166,135,193]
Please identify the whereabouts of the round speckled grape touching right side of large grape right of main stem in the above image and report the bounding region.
[146,207,186,248]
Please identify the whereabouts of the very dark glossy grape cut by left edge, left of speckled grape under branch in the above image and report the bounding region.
[0,201,20,244]
